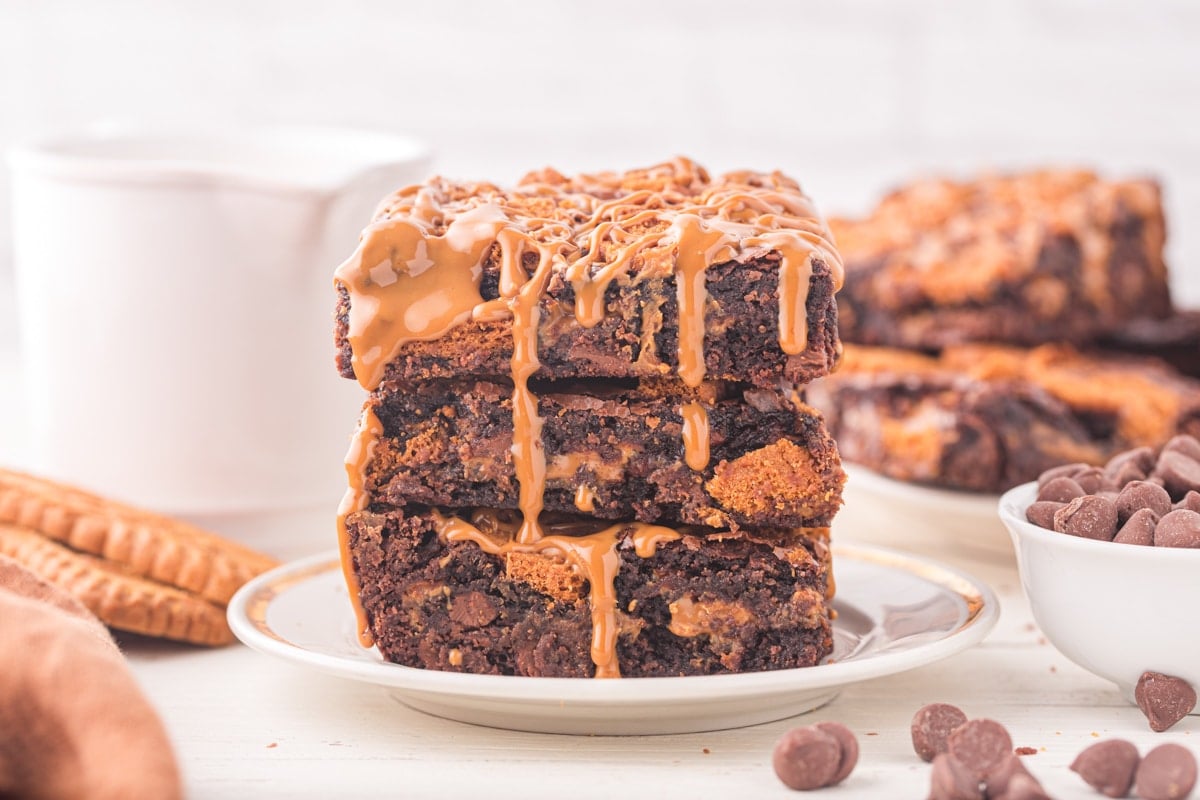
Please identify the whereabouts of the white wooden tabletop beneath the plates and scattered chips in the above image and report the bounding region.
[0,349,1200,799]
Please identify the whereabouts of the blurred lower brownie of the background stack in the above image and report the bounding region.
[808,345,1200,492]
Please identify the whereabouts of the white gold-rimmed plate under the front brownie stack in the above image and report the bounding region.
[229,545,1000,734]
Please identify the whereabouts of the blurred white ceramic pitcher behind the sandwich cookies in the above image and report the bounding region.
[10,128,428,515]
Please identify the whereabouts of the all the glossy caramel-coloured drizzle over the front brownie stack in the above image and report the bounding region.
[336,158,842,678]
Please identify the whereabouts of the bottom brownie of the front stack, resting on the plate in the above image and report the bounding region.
[347,506,833,678]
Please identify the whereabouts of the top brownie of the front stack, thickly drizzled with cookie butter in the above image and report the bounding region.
[336,158,841,389]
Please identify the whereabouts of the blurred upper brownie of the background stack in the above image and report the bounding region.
[829,170,1170,350]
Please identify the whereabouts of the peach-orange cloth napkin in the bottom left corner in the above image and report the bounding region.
[0,557,182,800]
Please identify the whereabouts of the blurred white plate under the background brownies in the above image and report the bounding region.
[833,464,1014,564]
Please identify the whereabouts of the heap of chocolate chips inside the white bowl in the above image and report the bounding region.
[1025,434,1200,547]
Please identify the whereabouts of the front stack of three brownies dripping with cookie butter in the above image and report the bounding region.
[335,160,845,678]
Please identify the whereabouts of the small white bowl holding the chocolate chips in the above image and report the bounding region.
[1000,483,1200,702]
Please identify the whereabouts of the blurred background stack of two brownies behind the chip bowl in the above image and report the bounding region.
[809,170,1200,492]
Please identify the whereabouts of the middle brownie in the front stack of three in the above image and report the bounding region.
[367,380,845,528]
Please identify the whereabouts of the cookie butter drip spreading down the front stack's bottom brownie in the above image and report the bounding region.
[434,511,680,678]
